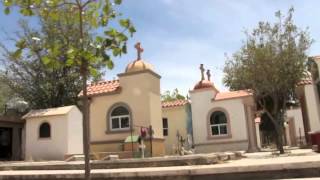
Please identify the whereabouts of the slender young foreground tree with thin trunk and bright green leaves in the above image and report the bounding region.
[3,0,136,179]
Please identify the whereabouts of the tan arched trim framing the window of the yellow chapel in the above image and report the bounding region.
[105,102,133,134]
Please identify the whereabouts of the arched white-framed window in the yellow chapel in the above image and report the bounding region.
[110,106,130,130]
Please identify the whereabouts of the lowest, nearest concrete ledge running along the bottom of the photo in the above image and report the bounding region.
[0,157,320,180]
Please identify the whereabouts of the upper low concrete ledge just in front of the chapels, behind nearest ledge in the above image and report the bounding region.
[0,153,235,171]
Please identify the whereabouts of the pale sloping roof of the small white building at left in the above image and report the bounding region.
[22,105,76,119]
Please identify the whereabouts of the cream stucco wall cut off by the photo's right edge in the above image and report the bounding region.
[304,84,320,131]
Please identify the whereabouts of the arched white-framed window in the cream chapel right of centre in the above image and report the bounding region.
[210,111,228,136]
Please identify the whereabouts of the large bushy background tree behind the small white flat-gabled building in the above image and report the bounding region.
[0,16,90,109]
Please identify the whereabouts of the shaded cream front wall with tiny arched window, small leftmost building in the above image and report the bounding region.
[26,116,68,160]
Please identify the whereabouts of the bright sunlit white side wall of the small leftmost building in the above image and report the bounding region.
[67,107,83,154]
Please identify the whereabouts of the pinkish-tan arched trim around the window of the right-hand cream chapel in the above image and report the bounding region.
[207,107,232,140]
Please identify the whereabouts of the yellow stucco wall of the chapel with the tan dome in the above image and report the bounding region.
[90,72,163,154]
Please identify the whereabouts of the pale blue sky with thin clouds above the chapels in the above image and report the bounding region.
[0,0,320,95]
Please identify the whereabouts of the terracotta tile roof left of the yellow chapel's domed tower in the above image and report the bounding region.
[78,80,120,96]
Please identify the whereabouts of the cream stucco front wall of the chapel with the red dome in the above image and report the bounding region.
[191,90,248,152]
